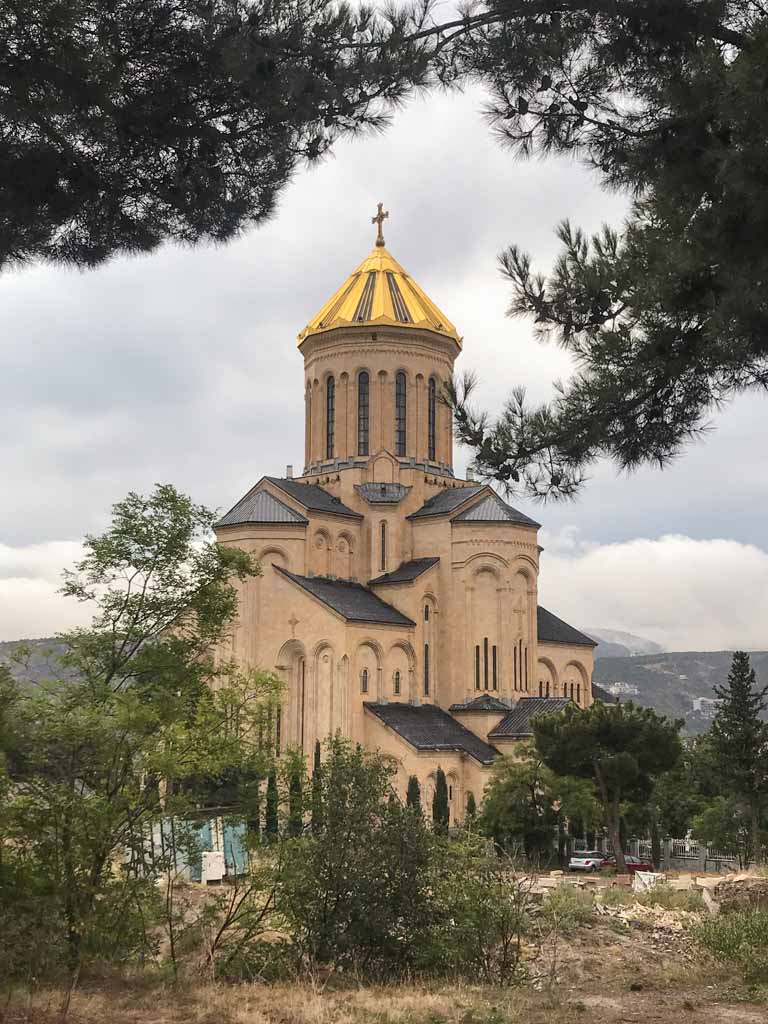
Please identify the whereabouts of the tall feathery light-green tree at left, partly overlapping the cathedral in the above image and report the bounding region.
[0,485,279,972]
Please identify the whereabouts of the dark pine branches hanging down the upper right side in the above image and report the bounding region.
[438,0,768,498]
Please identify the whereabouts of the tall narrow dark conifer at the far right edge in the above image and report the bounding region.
[710,651,768,861]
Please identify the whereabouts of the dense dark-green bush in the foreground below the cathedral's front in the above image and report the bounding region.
[278,738,436,977]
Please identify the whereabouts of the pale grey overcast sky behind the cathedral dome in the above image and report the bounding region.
[0,86,768,649]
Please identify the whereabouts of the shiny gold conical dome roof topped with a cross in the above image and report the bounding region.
[299,204,461,345]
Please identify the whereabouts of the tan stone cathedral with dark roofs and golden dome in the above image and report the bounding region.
[216,204,595,821]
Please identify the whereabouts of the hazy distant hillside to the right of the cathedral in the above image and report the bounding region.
[593,651,768,733]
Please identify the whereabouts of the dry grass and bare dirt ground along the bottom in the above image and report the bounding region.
[0,880,768,1024]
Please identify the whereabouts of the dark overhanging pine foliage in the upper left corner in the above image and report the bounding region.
[0,0,434,267]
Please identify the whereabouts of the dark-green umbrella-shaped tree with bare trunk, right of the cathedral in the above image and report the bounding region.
[532,701,682,872]
